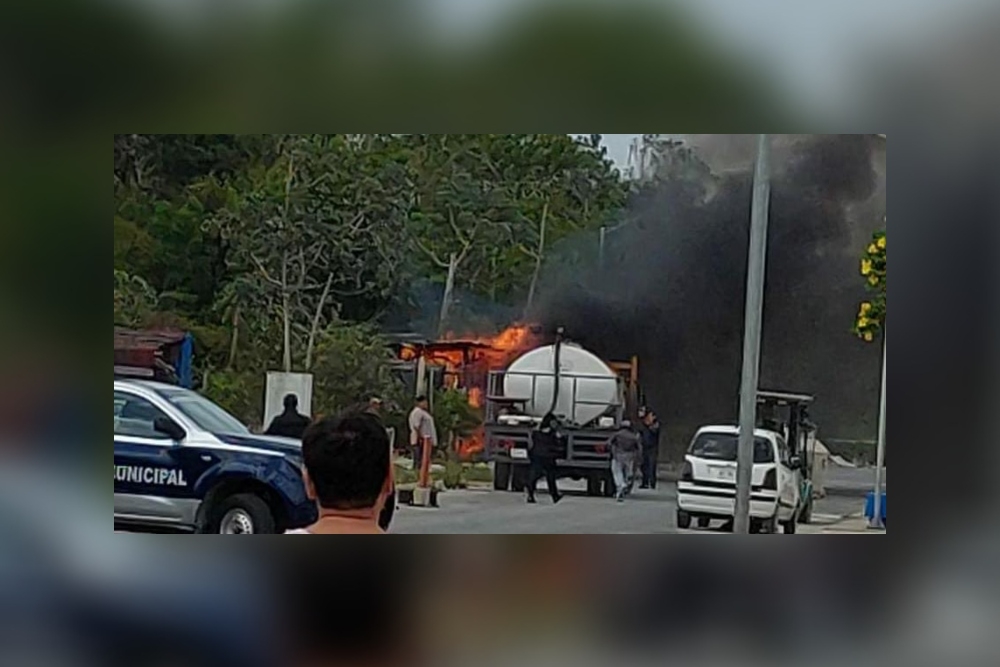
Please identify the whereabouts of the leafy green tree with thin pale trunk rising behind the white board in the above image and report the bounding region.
[202,135,409,371]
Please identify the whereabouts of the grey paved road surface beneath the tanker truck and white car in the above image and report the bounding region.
[392,482,862,535]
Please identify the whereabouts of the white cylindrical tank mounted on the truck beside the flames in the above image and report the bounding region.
[504,343,619,425]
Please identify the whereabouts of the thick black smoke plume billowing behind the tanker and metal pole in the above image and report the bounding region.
[537,135,885,458]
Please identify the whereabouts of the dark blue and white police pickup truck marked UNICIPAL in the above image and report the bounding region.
[114,380,317,535]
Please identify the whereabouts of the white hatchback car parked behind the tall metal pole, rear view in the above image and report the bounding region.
[677,426,802,534]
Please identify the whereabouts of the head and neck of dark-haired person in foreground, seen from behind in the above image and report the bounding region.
[302,412,392,534]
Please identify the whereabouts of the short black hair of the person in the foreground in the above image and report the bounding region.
[302,411,390,510]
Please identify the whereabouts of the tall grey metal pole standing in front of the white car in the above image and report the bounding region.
[734,134,771,535]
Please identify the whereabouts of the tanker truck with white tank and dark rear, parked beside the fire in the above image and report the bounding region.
[485,332,641,497]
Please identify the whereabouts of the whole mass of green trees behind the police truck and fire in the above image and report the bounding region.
[114,134,628,426]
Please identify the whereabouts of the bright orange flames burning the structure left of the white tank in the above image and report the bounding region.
[400,324,542,459]
